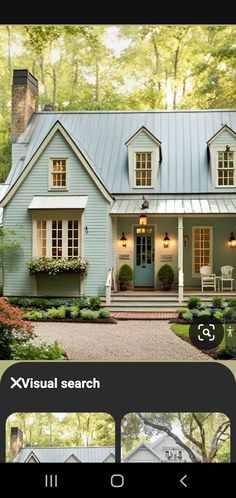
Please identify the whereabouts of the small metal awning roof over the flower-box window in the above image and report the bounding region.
[28,195,88,209]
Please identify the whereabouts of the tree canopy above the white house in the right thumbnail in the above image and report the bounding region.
[122,413,230,463]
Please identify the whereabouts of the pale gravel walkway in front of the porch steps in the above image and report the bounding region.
[35,320,214,361]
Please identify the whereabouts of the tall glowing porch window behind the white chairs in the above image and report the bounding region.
[193,227,212,277]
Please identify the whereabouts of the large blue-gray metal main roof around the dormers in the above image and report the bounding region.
[4,110,236,194]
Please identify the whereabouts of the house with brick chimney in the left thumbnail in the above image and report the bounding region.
[10,427,115,463]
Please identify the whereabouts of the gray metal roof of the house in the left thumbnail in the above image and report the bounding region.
[14,446,115,463]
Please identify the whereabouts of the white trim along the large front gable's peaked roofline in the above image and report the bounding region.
[1,121,113,207]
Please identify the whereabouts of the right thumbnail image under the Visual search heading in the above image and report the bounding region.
[121,413,230,463]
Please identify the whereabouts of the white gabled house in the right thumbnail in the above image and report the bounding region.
[123,434,194,463]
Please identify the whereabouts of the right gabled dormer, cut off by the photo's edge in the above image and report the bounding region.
[207,124,236,188]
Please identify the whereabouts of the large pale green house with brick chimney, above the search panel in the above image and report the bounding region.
[0,70,236,304]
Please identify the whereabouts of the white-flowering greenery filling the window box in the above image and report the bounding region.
[27,256,88,275]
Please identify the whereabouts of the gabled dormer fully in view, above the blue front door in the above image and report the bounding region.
[125,126,161,189]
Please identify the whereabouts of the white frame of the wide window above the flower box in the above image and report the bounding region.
[32,210,82,258]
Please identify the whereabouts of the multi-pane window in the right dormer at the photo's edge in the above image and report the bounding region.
[217,150,235,187]
